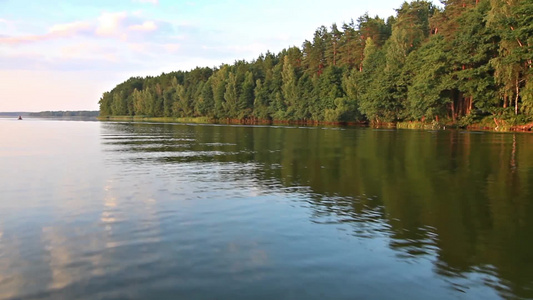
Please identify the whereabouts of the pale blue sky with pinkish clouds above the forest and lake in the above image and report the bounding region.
[0,0,434,112]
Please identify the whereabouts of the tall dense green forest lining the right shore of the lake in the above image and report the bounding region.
[99,0,533,123]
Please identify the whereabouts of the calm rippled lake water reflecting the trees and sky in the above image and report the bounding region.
[0,119,533,299]
